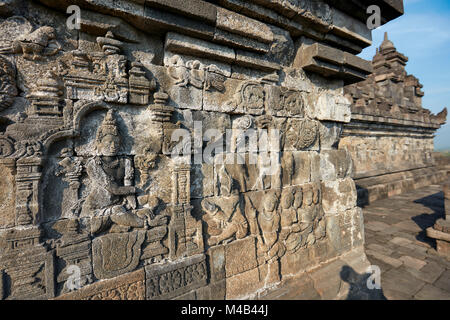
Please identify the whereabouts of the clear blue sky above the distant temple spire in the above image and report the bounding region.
[359,0,450,150]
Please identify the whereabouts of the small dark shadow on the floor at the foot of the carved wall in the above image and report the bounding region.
[340,266,387,300]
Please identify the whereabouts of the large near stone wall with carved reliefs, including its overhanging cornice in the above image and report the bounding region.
[0,0,403,299]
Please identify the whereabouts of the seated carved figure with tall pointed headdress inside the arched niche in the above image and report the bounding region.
[81,111,146,233]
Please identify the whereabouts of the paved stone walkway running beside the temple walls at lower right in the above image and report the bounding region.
[363,186,450,300]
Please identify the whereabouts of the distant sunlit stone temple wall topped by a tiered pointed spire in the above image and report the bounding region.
[339,34,450,204]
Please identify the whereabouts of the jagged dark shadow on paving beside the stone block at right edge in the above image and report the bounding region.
[411,192,445,249]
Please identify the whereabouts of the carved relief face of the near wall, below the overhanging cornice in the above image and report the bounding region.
[0,2,370,299]
